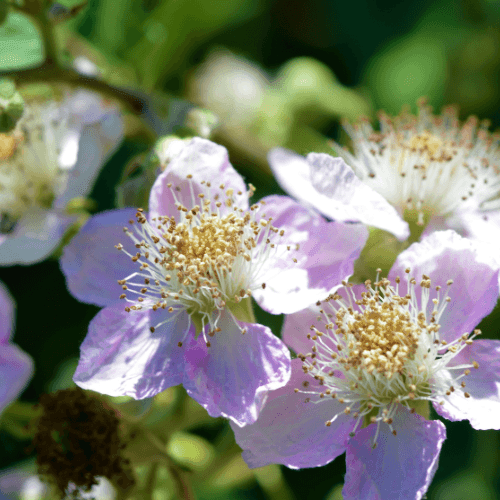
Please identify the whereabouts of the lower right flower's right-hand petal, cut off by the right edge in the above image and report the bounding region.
[434,340,500,430]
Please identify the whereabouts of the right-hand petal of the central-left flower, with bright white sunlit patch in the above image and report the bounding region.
[254,196,368,314]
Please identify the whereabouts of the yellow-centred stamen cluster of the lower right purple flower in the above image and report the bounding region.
[295,269,481,446]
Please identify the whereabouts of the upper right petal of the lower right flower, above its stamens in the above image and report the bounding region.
[389,231,498,342]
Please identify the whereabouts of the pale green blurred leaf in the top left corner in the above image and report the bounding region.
[0,12,43,71]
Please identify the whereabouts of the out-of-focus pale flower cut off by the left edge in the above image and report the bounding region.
[0,91,123,265]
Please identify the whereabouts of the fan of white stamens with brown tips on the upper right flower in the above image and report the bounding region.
[335,100,500,225]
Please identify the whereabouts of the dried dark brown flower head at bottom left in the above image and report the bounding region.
[33,387,134,498]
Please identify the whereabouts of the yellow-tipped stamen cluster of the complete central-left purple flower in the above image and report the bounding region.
[116,179,284,345]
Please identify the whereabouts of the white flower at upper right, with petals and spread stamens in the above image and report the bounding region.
[269,100,500,258]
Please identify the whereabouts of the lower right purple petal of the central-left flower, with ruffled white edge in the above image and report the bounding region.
[184,313,290,425]
